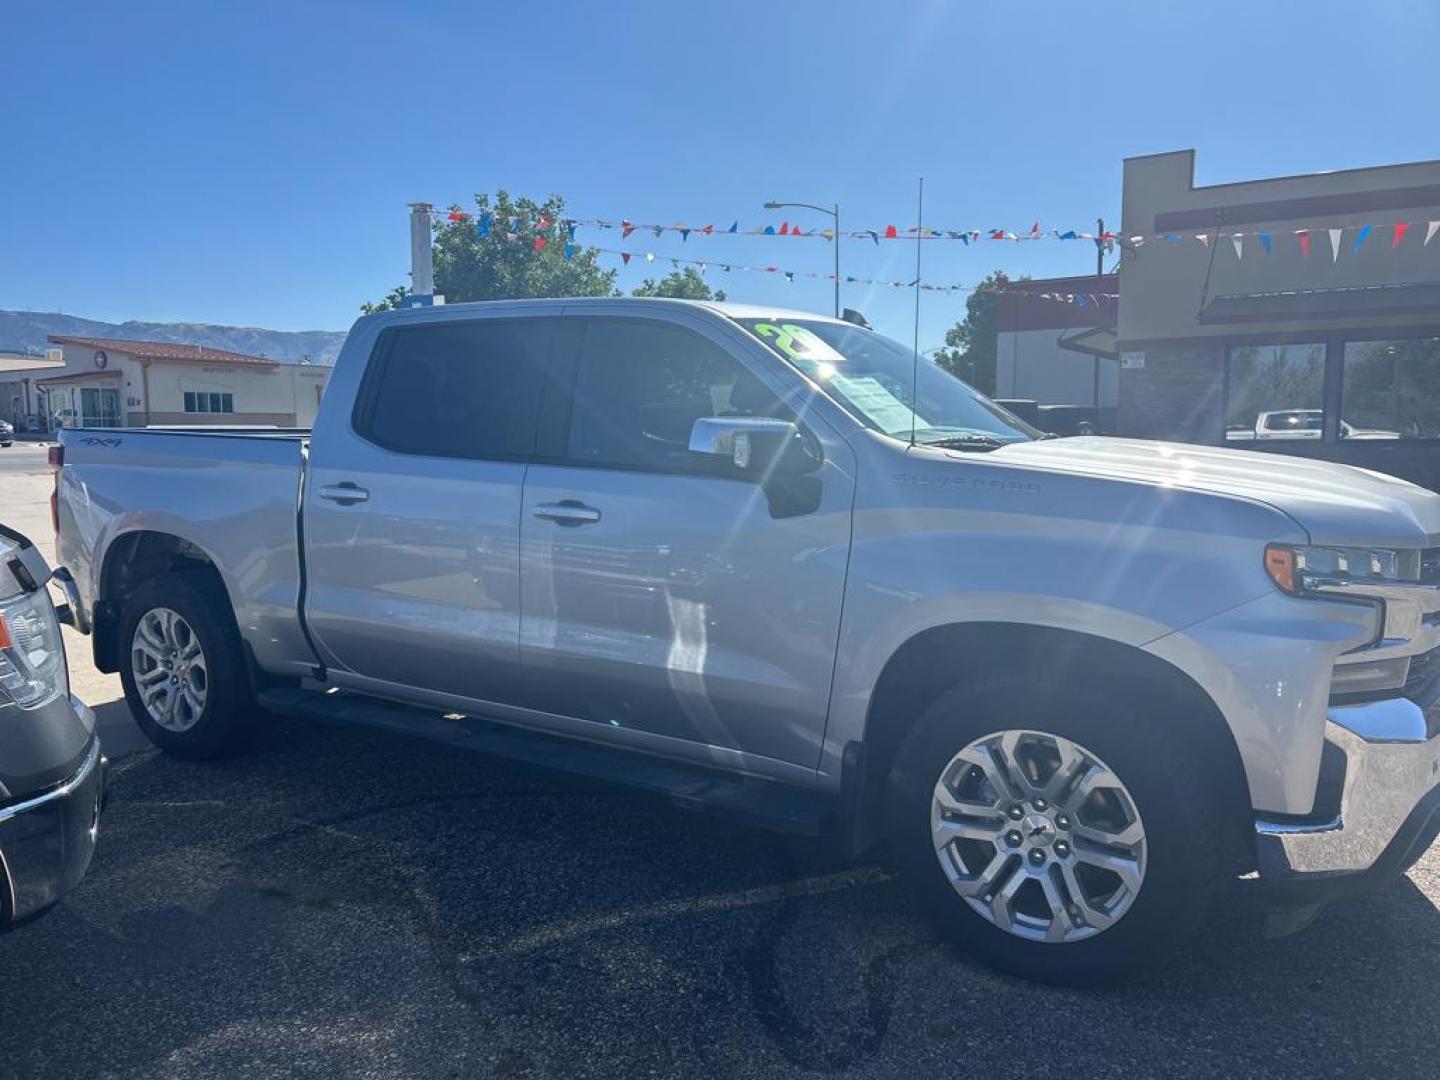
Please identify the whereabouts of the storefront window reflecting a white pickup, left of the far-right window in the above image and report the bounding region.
[1225,343,1325,439]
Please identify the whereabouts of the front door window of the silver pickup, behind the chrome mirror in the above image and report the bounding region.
[566,318,791,471]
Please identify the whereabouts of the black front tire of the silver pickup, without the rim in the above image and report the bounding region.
[890,678,1224,985]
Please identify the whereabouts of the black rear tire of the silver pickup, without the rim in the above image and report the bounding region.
[120,570,258,759]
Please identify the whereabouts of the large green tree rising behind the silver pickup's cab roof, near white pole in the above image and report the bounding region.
[361,190,619,314]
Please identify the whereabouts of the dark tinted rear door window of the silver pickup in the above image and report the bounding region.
[356,320,549,458]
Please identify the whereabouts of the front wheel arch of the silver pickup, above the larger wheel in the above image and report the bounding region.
[841,622,1253,870]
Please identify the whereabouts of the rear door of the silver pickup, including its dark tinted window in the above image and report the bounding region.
[304,318,554,701]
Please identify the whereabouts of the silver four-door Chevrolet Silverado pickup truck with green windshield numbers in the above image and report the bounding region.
[58,300,1440,981]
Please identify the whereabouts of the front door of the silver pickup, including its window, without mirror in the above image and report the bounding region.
[520,317,854,768]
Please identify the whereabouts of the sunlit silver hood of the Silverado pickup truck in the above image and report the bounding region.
[994,436,1440,547]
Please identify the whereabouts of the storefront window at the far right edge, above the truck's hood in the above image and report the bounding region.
[1341,337,1440,439]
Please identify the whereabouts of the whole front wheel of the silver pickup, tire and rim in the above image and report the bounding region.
[890,680,1221,985]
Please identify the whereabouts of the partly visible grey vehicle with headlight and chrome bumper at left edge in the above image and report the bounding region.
[0,526,105,930]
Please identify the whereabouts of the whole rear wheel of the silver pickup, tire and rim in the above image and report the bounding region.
[120,572,256,757]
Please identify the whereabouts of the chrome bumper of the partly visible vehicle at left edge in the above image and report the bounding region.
[0,722,107,926]
